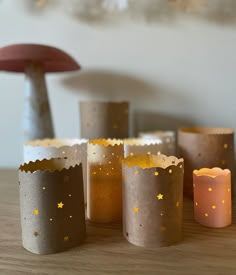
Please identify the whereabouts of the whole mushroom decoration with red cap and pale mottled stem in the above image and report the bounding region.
[0,44,80,141]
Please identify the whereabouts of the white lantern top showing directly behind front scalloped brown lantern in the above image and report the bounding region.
[124,138,162,157]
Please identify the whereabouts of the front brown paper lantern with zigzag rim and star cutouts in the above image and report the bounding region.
[19,159,85,254]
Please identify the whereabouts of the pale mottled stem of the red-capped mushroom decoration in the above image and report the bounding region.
[23,63,54,142]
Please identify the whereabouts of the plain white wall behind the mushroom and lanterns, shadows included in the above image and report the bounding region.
[0,0,236,167]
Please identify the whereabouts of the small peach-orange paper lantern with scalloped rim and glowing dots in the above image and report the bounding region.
[193,168,232,228]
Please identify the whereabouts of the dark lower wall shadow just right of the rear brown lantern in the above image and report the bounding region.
[134,111,194,136]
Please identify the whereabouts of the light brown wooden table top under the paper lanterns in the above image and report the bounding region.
[0,170,236,275]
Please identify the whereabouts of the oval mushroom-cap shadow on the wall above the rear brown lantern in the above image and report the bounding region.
[62,70,157,102]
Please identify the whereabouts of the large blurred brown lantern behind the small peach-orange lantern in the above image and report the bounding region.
[178,128,234,197]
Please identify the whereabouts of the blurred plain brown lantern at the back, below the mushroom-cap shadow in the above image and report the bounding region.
[80,101,129,139]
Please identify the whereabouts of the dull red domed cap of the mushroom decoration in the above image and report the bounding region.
[0,44,80,72]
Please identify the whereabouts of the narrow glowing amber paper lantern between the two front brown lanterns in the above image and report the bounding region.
[87,139,124,223]
